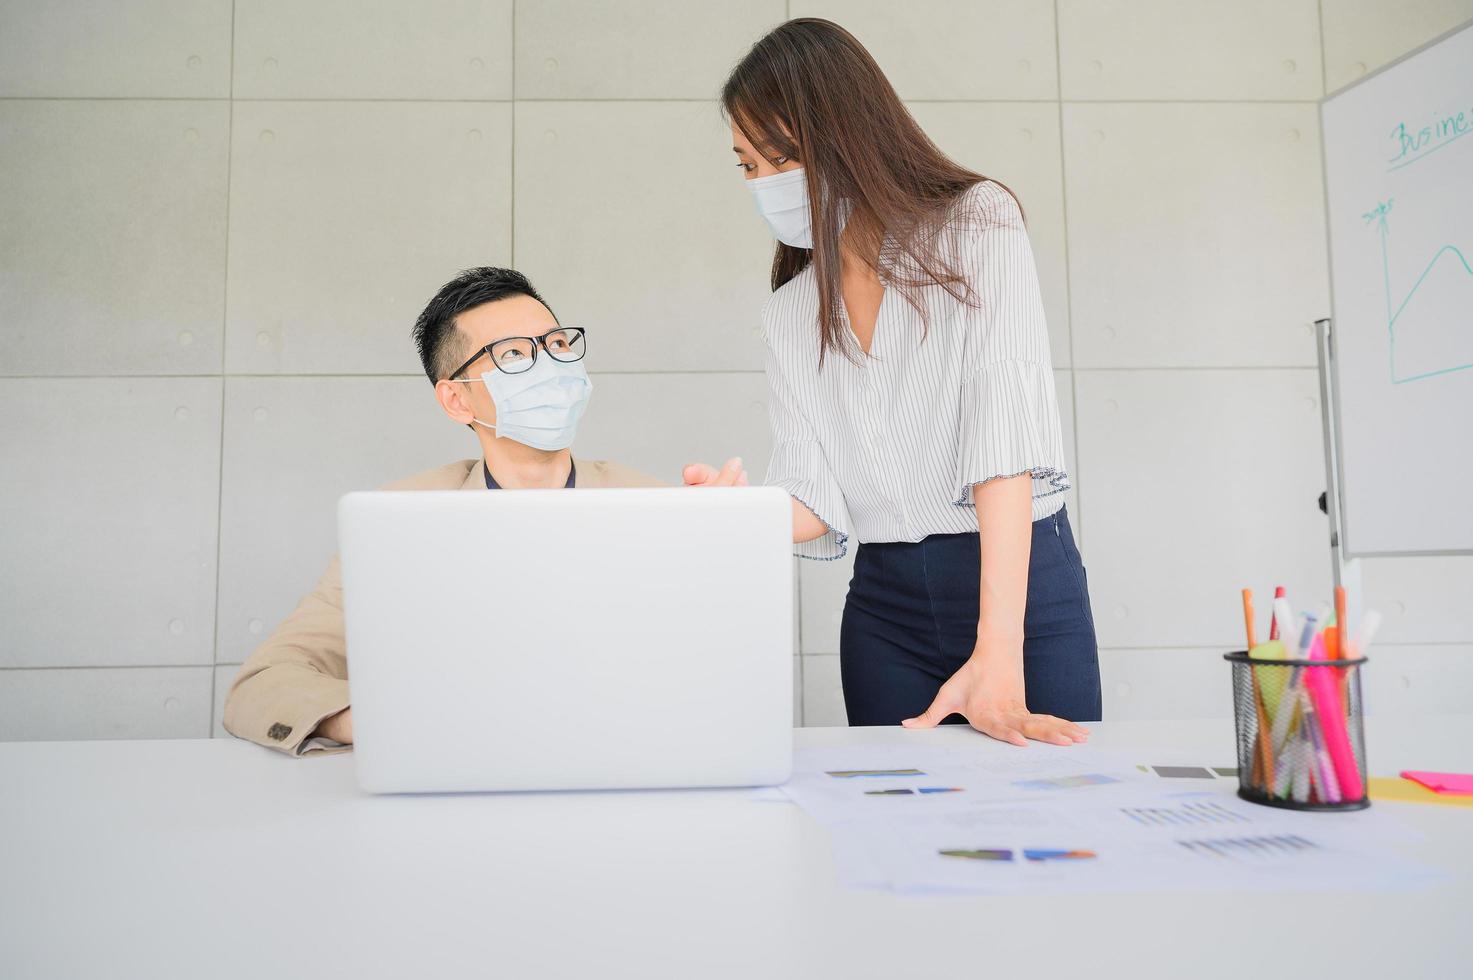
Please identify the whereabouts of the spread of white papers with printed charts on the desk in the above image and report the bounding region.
[782,743,1436,893]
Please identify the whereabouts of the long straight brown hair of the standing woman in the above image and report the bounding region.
[722,18,1021,364]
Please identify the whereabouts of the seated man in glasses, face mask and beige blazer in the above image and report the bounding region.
[224,268,747,756]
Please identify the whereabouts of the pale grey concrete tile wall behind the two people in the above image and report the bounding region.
[0,0,1473,738]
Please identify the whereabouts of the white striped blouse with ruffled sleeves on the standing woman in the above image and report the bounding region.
[762,181,1069,560]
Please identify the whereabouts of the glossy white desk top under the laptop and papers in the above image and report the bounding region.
[0,716,1473,980]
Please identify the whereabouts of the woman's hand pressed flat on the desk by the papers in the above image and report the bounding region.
[900,653,1090,746]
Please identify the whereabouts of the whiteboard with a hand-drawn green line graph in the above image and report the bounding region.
[1320,22,1473,557]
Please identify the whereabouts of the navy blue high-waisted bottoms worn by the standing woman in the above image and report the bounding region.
[840,508,1100,725]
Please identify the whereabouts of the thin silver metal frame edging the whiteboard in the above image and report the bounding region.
[1317,19,1473,557]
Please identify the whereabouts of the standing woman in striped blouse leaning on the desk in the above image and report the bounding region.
[686,19,1100,744]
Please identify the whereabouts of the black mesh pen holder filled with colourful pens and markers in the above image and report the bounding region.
[1223,650,1370,811]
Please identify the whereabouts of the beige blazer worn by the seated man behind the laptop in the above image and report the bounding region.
[224,460,661,756]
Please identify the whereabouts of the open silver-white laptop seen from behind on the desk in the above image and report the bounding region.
[337,488,792,793]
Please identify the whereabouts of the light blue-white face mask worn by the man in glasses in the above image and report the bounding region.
[457,357,594,452]
